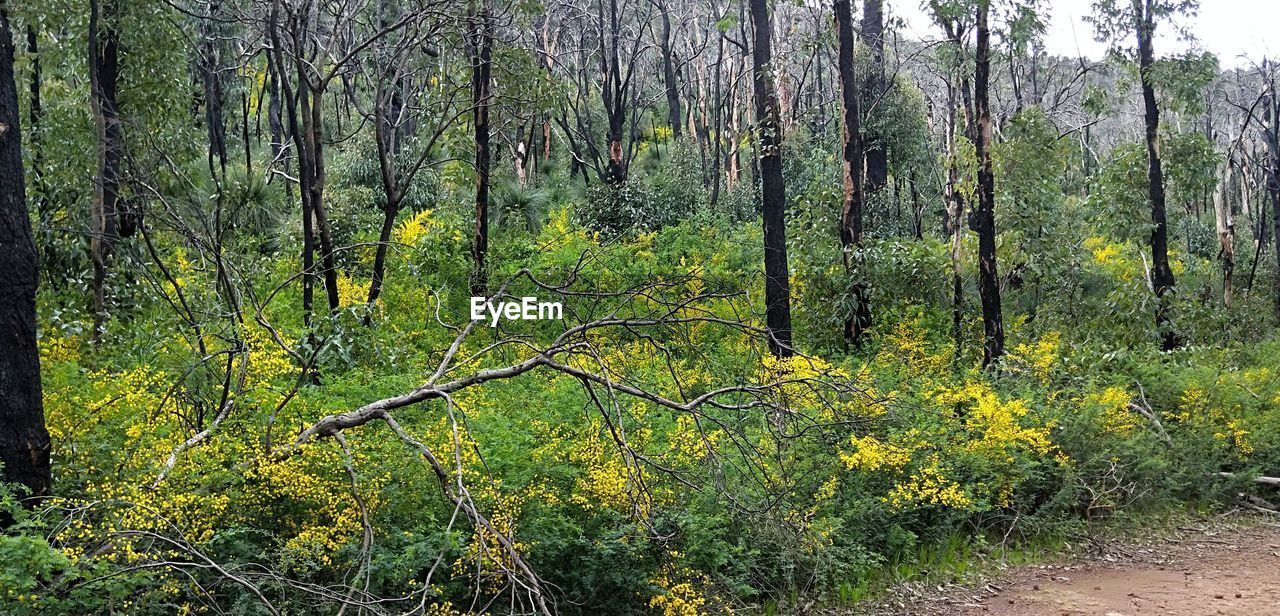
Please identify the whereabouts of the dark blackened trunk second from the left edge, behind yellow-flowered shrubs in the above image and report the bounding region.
[88,0,124,342]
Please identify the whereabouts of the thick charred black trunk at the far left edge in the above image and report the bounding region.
[0,0,54,504]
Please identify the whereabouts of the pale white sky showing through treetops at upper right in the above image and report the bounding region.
[884,0,1280,68]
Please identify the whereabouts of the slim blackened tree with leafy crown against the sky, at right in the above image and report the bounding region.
[1092,0,1197,351]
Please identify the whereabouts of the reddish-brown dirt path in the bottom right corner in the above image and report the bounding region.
[880,521,1280,616]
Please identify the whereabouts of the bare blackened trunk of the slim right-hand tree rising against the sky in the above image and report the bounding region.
[1134,0,1178,351]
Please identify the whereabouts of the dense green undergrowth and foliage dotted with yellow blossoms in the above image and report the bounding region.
[10,0,1280,616]
